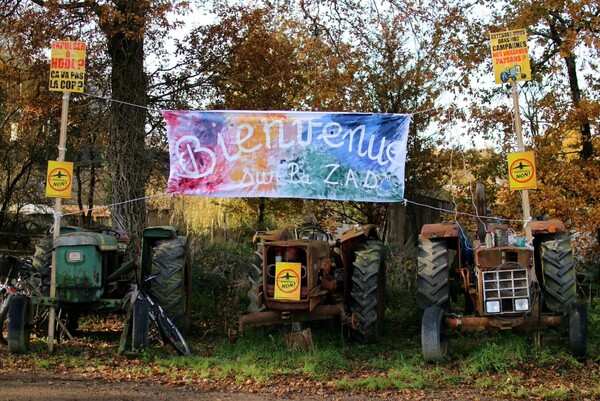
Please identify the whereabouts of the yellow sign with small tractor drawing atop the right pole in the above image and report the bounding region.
[490,29,531,84]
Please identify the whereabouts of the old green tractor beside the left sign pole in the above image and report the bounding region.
[8,226,191,353]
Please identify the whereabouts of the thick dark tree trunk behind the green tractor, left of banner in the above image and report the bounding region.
[103,0,149,250]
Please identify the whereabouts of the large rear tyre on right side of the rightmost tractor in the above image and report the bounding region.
[540,234,577,312]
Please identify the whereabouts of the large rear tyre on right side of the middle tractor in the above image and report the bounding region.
[350,241,385,343]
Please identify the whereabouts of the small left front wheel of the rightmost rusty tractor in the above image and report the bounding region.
[421,306,448,363]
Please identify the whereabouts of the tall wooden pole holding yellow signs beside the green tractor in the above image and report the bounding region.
[48,92,71,352]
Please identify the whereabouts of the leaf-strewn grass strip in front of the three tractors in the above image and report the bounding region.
[0,299,600,400]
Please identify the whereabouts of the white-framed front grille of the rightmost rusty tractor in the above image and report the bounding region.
[483,268,530,313]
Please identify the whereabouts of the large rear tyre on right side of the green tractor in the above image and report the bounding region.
[149,236,192,333]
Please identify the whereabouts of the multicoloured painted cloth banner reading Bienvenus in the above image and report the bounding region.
[163,110,411,202]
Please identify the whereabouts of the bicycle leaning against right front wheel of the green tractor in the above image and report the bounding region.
[119,275,191,356]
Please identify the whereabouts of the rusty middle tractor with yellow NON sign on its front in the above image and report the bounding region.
[238,225,385,342]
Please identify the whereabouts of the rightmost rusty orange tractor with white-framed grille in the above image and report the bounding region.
[418,184,587,362]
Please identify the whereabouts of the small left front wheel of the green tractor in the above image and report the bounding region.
[8,294,31,354]
